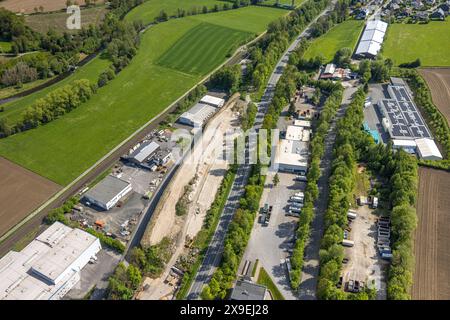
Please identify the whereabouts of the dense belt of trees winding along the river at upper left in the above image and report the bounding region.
[0,0,142,87]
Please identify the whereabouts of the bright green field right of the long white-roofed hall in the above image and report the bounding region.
[383,19,450,67]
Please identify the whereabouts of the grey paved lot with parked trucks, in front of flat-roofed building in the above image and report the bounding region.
[239,172,304,300]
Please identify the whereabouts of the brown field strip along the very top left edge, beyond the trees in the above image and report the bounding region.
[0,0,104,13]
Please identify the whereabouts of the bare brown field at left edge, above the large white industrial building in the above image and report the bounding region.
[0,157,61,236]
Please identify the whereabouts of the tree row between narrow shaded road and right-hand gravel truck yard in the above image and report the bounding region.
[317,89,373,300]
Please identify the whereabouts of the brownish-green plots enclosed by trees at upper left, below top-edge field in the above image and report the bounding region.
[25,6,108,33]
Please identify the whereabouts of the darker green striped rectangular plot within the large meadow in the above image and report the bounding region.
[158,23,252,75]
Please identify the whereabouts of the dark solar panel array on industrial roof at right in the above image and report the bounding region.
[379,86,431,139]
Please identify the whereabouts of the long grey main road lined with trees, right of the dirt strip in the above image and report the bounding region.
[187,1,335,300]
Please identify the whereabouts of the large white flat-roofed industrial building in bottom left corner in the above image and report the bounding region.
[0,222,101,300]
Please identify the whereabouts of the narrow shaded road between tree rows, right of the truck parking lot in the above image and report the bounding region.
[299,87,357,300]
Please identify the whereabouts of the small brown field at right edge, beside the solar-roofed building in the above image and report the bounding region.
[419,68,450,124]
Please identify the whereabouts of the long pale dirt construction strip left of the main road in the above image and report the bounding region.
[138,98,241,300]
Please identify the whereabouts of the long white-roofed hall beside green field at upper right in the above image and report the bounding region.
[355,20,388,58]
